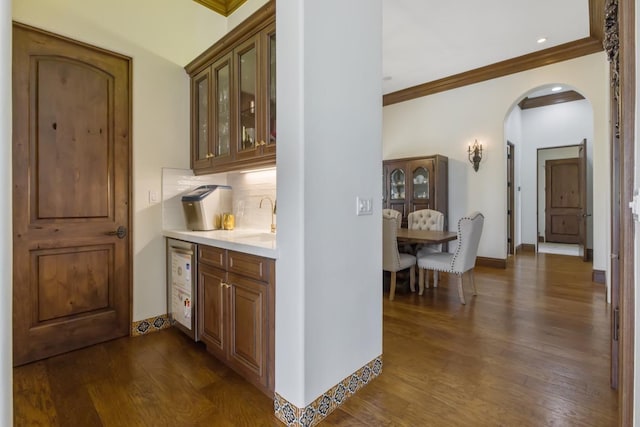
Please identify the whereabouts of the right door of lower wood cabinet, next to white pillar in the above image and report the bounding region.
[227,273,269,387]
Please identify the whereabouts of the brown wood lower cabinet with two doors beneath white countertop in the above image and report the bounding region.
[198,246,275,396]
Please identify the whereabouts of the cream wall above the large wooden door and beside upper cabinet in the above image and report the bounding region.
[13,0,226,321]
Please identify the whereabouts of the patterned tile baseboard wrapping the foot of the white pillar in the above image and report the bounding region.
[273,355,382,427]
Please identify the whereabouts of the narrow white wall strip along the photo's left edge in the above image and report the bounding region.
[0,0,13,426]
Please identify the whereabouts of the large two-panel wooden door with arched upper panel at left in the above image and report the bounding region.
[13,24,131,365]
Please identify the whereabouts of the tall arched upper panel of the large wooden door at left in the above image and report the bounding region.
[35,56,114,219]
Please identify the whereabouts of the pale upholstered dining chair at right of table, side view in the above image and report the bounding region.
[417,212,484,304]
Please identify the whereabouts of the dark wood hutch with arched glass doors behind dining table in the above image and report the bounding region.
[382,155,449,229]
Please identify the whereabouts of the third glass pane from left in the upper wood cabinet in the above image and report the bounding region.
[236,40,258,152]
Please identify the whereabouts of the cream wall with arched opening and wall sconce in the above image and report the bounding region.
[383,53,610,270]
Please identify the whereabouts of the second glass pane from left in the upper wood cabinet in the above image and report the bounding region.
[213,55,231,161]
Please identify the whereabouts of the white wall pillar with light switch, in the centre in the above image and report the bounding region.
[276,0,382,407]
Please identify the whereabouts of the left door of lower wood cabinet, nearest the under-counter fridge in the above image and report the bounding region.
[198,263,227,360]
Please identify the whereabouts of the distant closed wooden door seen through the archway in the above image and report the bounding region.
[545,158,584,243]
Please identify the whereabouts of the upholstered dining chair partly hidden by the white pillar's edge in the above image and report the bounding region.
[382,217,416,301]
